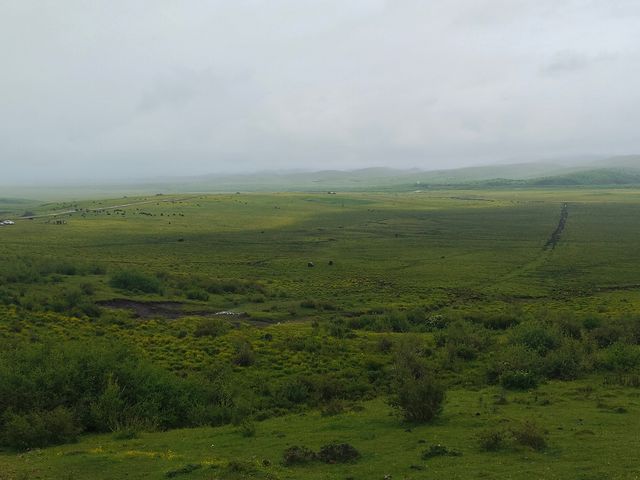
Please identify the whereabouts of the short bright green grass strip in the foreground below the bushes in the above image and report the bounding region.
[0,379,640,480]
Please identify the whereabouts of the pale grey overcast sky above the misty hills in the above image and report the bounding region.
[0,0,640,184]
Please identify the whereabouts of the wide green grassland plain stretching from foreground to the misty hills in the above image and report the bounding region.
[0,187,640,480]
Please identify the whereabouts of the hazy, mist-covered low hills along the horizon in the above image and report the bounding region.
[5,155,640,199]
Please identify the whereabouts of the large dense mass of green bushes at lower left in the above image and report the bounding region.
[0,341,215,449]
